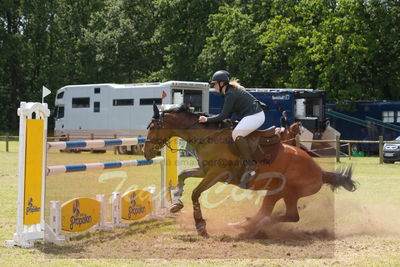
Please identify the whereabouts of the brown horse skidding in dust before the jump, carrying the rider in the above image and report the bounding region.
[144,105,356,237]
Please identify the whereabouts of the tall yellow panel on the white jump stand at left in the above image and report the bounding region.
[24,119,44,225]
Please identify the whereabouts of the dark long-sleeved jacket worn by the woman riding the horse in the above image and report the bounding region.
[207,85,263,122]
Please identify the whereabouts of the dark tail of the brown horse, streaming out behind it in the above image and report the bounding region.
[322,165,358,192]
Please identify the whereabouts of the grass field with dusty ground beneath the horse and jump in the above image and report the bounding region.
[0,142,400,266]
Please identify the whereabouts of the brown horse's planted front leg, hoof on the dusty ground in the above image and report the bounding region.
[192,170,229,237]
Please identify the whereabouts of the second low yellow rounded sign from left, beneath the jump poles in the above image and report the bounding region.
[121,190,153,221]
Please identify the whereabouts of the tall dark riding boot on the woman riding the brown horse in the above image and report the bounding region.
[235,136,257,187]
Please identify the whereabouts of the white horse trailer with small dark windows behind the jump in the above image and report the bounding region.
[54,81,209,153]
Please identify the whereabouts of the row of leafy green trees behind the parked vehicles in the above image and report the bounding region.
[0,0,400,130]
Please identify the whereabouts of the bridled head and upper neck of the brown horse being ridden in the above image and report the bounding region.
[144,104,198,159]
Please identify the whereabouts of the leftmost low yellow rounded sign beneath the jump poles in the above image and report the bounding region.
[61,198,100,232]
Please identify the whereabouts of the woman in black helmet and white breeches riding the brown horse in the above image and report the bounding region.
[199,70,265,184]
